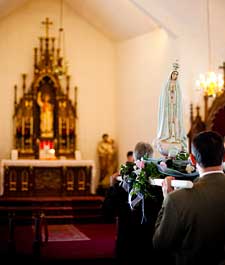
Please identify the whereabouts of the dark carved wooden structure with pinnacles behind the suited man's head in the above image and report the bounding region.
[188,62,225,152]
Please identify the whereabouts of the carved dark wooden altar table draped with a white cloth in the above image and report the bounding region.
[0,159,95,196]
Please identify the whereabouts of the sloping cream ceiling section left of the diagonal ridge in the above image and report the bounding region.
[66,0,157,40]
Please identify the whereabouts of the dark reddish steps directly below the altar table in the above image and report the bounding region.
[0,196,103,222]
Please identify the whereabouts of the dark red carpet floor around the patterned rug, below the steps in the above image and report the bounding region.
[0,224,116,261]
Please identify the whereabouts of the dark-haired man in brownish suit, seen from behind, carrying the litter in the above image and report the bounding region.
[153,131,225,265]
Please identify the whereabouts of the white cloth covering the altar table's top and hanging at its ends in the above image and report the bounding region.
[0,159,96,196]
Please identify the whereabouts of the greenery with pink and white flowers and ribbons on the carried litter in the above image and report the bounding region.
[120,152,198,218]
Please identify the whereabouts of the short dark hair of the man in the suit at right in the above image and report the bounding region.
[192,131,224,168]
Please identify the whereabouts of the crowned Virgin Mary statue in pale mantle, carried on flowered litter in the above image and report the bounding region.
[156,63,187,156]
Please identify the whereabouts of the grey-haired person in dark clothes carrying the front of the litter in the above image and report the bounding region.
[103,142,163,265]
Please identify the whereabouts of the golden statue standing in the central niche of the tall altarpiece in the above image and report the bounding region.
[37,92,54,137]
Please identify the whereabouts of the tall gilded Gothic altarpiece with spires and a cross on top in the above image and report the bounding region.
[13,18,77,159]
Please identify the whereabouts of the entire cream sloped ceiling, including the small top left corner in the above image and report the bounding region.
[0,0,211,41]
